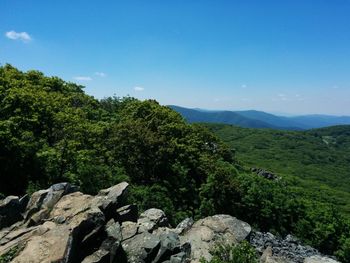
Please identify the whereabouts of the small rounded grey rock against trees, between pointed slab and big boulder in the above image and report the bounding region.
[137,208,169,232]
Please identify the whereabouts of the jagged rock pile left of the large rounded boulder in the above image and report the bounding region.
[0,183,191,263]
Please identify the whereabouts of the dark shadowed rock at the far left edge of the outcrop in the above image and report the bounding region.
[0,196,23,229]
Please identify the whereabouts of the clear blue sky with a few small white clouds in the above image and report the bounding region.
[0,0,350,115]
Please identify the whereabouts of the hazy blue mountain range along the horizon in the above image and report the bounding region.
[169,105,350,130]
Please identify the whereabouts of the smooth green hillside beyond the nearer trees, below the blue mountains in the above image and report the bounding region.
[205,124,350,215]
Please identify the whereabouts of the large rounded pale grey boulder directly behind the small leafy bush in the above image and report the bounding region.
[180,215,251,262]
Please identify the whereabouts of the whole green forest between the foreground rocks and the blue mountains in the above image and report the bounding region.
[0,64,350,262]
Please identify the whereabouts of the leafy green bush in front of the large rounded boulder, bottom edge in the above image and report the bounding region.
[200,240,258,263]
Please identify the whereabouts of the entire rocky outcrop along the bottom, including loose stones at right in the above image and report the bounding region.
[0,182,336,263]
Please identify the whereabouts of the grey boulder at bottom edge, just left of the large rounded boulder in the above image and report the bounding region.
[122,232,160,263]
